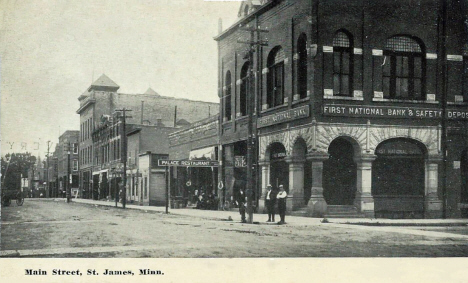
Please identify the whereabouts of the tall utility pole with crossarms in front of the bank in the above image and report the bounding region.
[237,25,268,224]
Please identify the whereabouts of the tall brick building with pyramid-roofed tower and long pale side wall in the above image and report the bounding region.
[77,75,219,203]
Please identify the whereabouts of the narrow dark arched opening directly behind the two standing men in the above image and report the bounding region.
[270,143,289,193]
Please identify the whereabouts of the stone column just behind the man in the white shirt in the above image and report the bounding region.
[286,158,305,212]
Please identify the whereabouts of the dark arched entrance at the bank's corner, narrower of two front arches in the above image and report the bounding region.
[323,138,357,205]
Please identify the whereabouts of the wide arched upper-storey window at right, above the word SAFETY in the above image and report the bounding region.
[382,36,426,100]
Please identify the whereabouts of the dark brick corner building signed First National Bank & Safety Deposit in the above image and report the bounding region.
[215,0,468,218]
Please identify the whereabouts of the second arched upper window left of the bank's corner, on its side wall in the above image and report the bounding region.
[267,47,285,107]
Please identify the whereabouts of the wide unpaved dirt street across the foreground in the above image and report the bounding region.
[1,199,468,258]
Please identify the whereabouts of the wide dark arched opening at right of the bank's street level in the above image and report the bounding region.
[372,138,425,218]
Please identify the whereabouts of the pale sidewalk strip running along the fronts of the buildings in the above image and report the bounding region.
[69,199,468,226]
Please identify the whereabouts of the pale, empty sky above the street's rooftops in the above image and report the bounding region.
[0,0,241,160]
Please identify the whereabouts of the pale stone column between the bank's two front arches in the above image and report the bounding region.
[354,154,377,218]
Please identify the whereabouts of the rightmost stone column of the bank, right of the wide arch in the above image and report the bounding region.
[424,157,443,218]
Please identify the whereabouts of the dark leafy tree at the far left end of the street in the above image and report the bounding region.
[1,152,36,189]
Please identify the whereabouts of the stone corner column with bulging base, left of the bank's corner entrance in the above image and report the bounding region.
[307,153,329,217]
